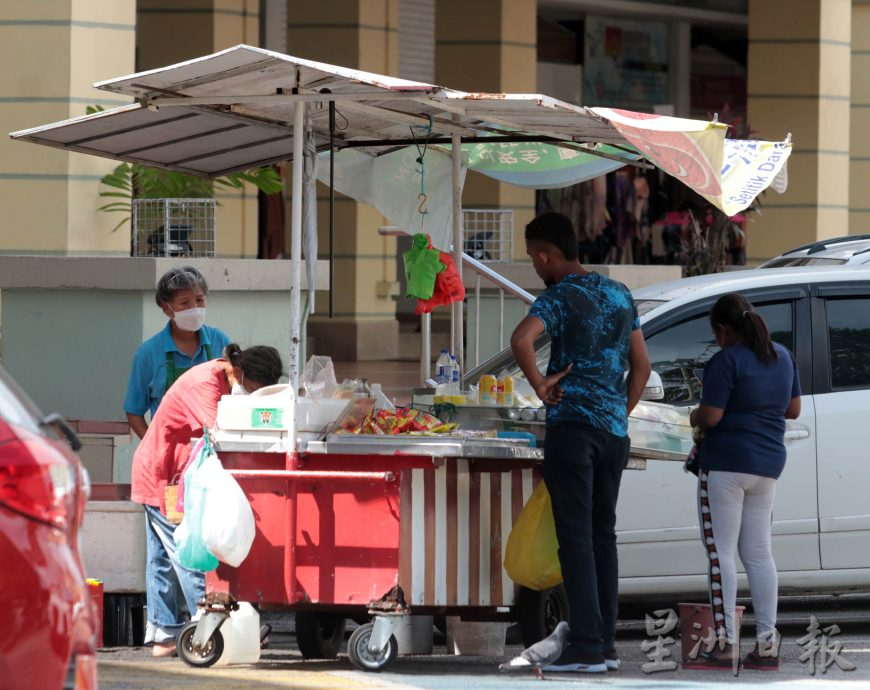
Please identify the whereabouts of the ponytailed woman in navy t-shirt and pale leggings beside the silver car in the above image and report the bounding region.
[690,293,801,670]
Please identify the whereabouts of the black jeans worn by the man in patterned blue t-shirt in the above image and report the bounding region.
[544,425,630,663]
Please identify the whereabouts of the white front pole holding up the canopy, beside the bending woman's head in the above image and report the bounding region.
[288,101,305,451]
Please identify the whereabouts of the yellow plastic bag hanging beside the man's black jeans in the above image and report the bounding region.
[504,482,562,590]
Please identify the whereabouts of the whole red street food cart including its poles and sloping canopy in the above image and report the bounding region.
[12,46,791,670]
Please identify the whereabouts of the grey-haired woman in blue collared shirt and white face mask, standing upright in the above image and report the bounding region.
[124,266,230,438]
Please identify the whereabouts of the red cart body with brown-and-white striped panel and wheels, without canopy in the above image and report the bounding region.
[187,395,690,670]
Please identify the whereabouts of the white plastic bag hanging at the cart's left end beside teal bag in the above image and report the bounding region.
[200,454,256,568]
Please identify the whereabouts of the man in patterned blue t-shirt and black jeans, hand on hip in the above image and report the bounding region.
[511,213,650,673]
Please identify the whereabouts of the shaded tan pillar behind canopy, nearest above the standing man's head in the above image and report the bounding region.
[435,0,538,259]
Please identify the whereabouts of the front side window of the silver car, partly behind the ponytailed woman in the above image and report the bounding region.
[646,301,794,404]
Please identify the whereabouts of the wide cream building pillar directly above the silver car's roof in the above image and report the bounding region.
[747,0,852,263]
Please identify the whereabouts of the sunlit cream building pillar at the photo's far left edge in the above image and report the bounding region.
[0,0,136,255]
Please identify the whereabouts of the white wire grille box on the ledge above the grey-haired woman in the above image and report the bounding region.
[133,199,216,257]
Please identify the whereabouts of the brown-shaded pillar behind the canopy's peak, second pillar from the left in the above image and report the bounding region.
[137,0,262,258]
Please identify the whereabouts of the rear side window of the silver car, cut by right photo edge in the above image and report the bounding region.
[825,297,870,389]
